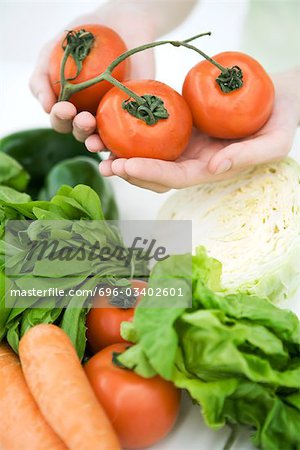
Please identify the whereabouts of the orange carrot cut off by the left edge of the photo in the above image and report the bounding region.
[0,344,66,450]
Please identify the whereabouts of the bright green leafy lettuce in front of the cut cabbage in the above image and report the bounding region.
[118,248,300,450]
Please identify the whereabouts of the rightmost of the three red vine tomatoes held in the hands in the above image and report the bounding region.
[182,52,274,139]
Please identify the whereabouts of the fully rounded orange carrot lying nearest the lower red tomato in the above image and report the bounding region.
[19,324,120,450]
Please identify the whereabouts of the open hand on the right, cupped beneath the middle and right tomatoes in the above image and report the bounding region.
[96,70,300,192]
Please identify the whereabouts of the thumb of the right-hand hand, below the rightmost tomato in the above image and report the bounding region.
[208,130,289,175]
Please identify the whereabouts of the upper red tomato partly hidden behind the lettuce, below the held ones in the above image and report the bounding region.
[86,280,148,353]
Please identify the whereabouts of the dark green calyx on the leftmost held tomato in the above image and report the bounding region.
[62,29,95,81]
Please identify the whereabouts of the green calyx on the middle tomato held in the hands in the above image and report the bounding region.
[122,94,169,125]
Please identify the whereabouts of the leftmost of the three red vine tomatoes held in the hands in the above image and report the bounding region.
[49,25,129,114]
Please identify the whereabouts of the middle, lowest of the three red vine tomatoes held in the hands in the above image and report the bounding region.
[97,80,192,161]
